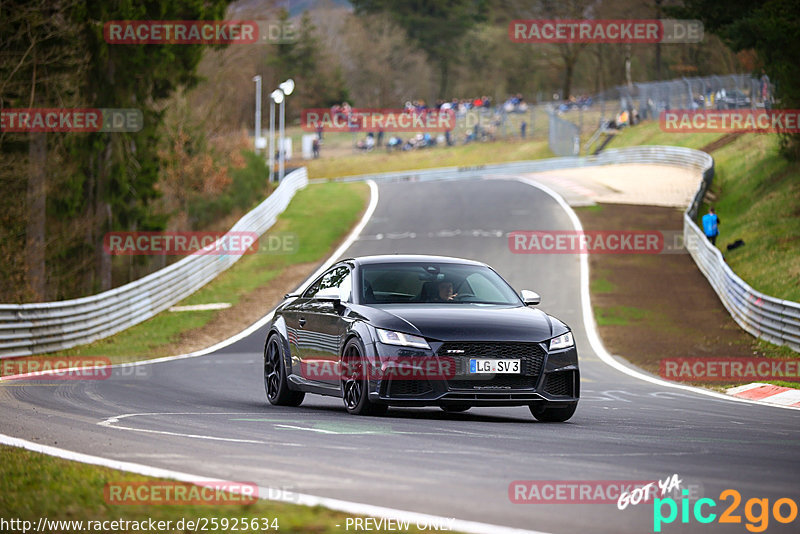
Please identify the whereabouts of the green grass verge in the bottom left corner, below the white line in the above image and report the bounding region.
[0,446,446,534]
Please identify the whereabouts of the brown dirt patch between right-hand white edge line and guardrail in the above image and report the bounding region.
[577,204,776,373]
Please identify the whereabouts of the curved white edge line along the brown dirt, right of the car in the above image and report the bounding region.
[516,176,800,410]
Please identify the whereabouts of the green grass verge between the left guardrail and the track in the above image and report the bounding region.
[54,183,369,363]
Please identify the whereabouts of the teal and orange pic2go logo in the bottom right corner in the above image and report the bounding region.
[653,489,797,532]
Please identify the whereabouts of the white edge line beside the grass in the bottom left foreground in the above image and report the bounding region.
[0,434,547,534]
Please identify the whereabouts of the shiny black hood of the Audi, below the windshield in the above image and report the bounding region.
[364,304,567,342]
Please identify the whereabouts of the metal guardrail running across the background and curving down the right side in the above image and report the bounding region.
[313,146,800,352]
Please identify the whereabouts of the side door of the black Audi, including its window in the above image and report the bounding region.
[298,265,352,387]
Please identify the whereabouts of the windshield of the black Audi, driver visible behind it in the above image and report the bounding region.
[361,263,521,305]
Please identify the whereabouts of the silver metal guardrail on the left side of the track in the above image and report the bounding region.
[0,168,308,358]
